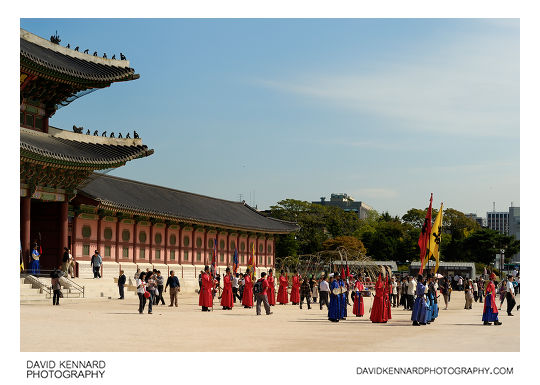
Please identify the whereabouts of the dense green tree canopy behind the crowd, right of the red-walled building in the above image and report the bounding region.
[270,199,519,264]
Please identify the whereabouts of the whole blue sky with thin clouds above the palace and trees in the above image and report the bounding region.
[21,19,520,216]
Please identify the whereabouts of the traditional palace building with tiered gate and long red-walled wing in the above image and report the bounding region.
[20,29,298,277]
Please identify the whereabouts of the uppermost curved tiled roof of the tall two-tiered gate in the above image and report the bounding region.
[20,37,139,83]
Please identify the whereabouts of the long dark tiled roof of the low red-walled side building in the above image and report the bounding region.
[79,173,298,234]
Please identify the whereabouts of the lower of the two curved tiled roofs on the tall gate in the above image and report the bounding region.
[20,128,154,169]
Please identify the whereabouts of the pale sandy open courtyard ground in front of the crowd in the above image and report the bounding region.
[20,292,520,352]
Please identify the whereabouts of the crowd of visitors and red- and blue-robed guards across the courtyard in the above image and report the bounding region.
[43,255,520,326]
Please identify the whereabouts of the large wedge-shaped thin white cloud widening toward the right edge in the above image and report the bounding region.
[256,30,519,137]
